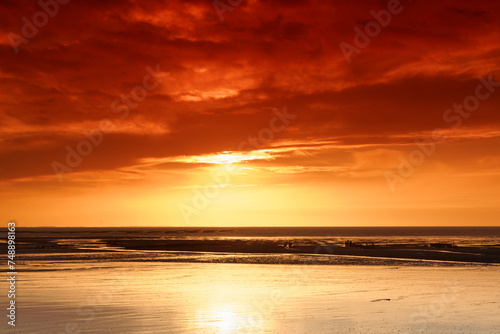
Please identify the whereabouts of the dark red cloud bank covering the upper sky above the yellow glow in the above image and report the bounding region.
[0,0,500,180]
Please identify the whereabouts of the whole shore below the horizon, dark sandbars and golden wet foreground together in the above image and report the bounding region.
[0,228,500,334]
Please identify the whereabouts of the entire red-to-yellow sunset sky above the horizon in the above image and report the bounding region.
[0,0,500,226]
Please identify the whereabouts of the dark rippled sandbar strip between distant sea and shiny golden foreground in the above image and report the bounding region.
[10,235,500,265]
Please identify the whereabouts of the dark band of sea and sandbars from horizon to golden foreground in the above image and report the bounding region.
[4,228,500,270]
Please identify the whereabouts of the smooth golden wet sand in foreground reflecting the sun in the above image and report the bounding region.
[0,262,500,334]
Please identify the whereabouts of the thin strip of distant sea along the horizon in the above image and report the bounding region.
[18,227,500,240]
